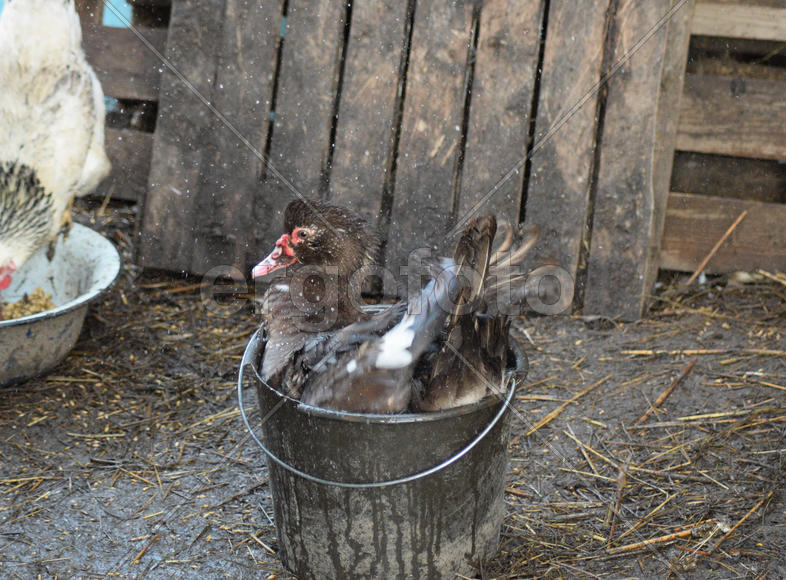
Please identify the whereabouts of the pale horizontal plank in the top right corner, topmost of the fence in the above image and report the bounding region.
[691,2,786,42]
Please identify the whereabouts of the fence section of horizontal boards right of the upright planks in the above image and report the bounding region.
[660,0,786,272]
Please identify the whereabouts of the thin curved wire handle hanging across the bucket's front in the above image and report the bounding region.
[237,330,516,489]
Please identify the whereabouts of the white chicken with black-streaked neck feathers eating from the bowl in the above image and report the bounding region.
[0,0,110,290]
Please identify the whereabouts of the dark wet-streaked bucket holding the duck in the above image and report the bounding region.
[238,332,526,579]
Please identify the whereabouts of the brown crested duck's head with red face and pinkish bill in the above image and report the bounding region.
[251,200,378,278]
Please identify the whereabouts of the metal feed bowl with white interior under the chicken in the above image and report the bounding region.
[0,224,120,386]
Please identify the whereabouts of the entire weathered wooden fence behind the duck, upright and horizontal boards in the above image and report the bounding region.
[75,0,786,319]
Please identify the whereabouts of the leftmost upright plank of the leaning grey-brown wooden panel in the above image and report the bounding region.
[138,0,224,271]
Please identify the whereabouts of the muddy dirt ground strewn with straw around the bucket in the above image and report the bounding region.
[0,201,786,579]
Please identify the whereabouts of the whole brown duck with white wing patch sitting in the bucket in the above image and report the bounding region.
[252,201,533,413]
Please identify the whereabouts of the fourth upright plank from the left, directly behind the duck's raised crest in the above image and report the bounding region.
[330,0,407,223]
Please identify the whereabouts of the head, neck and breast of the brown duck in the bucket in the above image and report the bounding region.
[251,199,380,396]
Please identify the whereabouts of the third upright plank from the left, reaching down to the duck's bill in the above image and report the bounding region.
[255,0,346,255]
